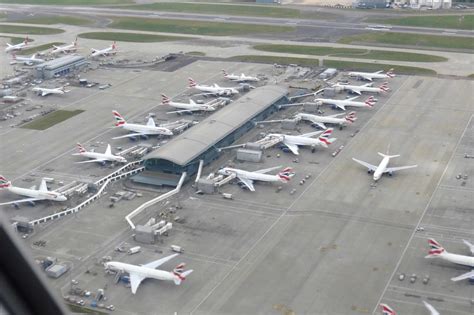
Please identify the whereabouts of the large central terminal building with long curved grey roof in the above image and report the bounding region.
[133,86,288,186]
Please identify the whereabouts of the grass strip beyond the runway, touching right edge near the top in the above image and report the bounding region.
[367,15,474,30]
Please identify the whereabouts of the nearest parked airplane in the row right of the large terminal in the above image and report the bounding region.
[218,166,295,191]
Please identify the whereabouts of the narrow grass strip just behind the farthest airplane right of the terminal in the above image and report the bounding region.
[323,59,436,75]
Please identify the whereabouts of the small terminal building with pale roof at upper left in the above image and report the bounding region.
[36,55,87,80]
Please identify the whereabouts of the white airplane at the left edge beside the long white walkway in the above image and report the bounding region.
[0,175,67,205]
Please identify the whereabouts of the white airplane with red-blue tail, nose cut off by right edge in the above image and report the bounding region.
[425,238,474,281]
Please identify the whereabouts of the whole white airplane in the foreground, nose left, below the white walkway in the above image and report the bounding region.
[104,254,193,294]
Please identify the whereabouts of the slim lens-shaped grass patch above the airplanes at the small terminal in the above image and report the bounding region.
[78,32,190,43]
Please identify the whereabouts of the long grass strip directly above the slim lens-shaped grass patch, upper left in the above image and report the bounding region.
[109,17,295,36]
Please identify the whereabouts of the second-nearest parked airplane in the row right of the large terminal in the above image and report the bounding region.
[265,128,337,155]
